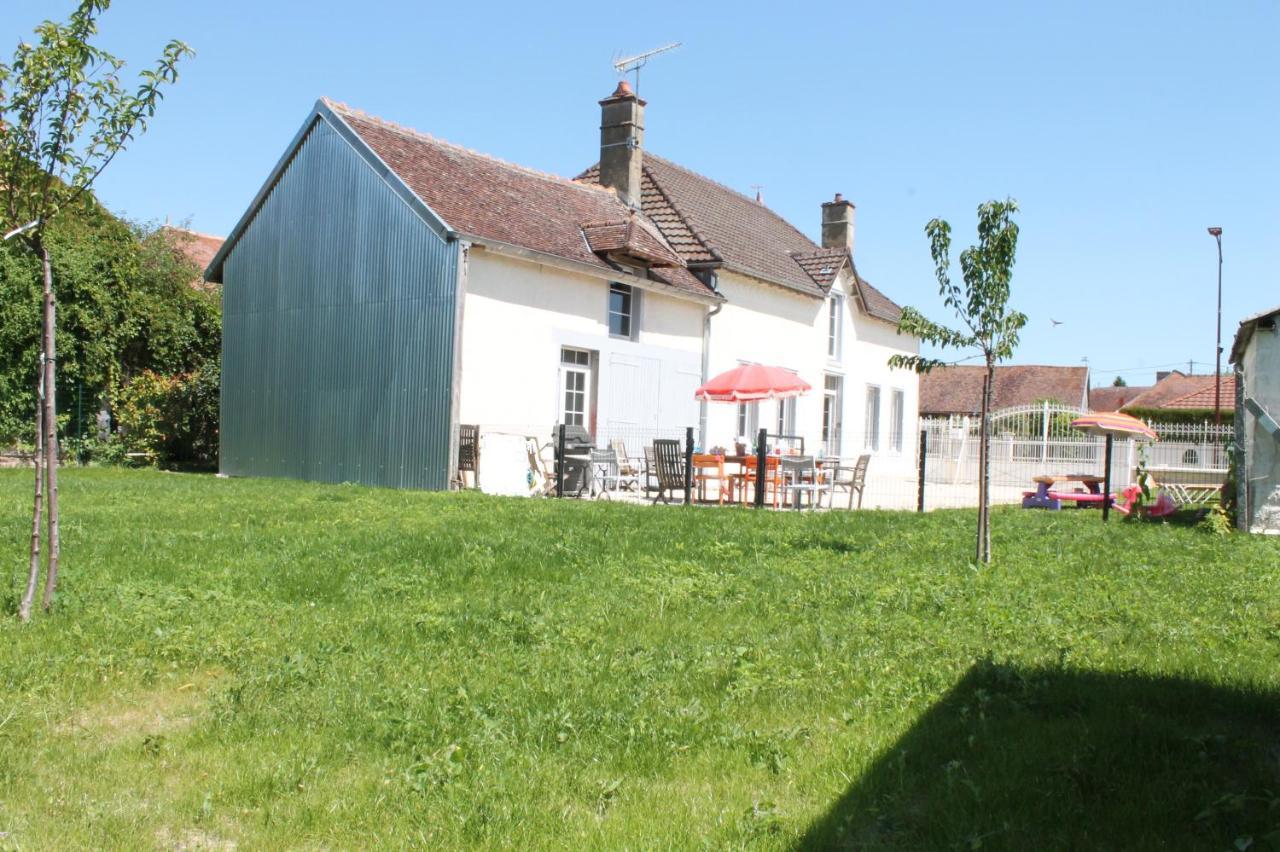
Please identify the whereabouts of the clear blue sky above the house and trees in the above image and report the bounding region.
[0,0,1280,384]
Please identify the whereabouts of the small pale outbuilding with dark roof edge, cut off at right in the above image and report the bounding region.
[1231,306,1280,535]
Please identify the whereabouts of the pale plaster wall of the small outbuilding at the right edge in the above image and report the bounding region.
[1236,329,1280,535]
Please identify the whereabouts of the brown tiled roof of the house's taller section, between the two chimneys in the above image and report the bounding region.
[579,151,902,324]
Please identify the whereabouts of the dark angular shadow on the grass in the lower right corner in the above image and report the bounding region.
[797,664,1280,849]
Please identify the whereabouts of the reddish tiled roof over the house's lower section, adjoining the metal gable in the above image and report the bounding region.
[324,100,714,297]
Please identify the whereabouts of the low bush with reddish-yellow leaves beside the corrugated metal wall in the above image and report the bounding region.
[114,361,221,468]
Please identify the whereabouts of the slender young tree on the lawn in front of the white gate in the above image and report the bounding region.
[890,198,1027,563]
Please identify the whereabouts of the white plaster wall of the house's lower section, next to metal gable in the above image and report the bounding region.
[460,247,707,440]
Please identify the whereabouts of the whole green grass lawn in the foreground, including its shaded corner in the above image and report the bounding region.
[0,469,1280,849]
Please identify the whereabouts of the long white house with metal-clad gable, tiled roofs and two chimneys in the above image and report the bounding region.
[206,83,918,489]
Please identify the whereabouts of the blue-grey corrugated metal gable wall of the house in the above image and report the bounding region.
[220,122,457,489]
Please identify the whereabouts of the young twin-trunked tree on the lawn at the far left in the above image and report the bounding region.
[0,0,191,620]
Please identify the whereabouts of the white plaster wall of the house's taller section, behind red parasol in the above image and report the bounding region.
[707,271,919,476]
